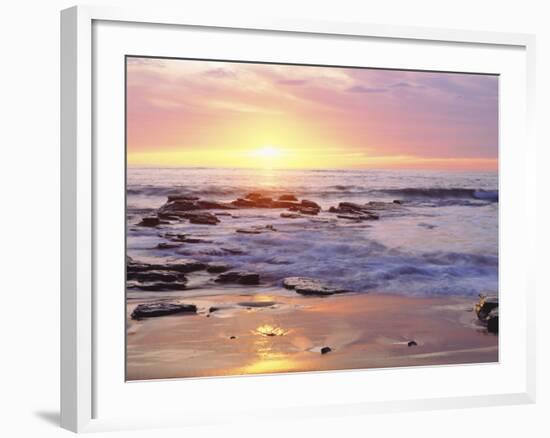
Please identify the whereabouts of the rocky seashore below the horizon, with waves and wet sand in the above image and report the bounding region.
[126,168,498,380]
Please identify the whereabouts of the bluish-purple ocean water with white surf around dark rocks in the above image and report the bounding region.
[127,168,499,296]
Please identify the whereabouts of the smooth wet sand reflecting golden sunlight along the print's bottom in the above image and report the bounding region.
[127,287,498,380]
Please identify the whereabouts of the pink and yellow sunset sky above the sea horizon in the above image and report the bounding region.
[126,57,498,171]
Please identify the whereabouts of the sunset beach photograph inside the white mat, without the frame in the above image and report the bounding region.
[127,55,499,381]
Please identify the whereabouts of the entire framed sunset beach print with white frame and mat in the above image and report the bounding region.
[61,7,534,431]
